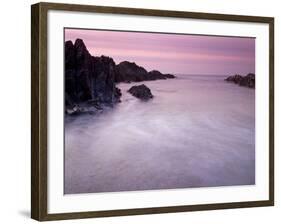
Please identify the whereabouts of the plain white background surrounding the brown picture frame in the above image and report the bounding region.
[0,0,281,224]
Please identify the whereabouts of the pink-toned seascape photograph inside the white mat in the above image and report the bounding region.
[64,28,255,194]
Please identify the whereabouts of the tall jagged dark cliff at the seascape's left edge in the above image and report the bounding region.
[65,39,121,114]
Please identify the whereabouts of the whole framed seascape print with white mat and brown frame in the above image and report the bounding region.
[31,3,274,221]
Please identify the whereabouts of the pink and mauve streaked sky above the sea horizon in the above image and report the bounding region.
[65,29,255,75]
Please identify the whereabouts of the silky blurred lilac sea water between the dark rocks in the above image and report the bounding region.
[64,75,255,194]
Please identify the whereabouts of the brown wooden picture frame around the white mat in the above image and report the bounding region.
[31,3,274,221]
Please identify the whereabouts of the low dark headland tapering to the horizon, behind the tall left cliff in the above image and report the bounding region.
[115,61,175,82]
